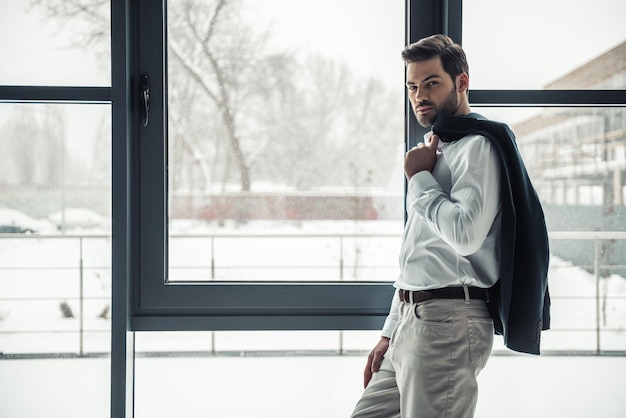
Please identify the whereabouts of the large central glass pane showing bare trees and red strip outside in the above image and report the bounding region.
[168,0,404,281]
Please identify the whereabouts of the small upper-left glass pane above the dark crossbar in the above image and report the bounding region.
[0,0,111,86]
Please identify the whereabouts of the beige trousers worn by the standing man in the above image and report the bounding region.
[352,299,494,418]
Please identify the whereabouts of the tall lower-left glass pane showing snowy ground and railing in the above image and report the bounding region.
[0,104,111,418]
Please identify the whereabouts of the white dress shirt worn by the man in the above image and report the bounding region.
[382,132,501,337]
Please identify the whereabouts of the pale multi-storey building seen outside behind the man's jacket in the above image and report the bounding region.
[513,41,626,206]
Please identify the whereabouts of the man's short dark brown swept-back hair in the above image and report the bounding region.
[402,34,469,80]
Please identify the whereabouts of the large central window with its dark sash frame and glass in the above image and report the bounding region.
[133,0,404,330]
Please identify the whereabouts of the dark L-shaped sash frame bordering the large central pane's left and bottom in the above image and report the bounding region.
[128,0,410,331]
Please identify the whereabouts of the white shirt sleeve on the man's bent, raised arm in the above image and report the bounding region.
[407,135,500,256]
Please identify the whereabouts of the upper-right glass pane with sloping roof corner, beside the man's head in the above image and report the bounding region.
[463,0,626,90]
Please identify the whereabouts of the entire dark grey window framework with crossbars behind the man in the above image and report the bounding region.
[0,0,626,330]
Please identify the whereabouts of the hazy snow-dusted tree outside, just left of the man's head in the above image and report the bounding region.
[246,55,403,190]
